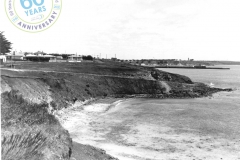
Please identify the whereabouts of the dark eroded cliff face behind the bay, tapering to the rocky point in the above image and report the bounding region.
[1,70,229,110]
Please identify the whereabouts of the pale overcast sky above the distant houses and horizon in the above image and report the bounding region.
[0,0,240,61]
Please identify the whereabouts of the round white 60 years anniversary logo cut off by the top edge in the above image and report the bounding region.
[5,0,62,33]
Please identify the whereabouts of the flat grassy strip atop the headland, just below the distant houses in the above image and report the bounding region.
[3,61,147,75]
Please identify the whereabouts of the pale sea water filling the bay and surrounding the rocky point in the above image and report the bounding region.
[61,66,240,160]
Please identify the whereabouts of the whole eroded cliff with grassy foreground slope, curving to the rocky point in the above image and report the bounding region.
[1,65,232,159]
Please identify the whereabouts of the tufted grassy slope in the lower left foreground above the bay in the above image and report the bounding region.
[1,90,72,160]
